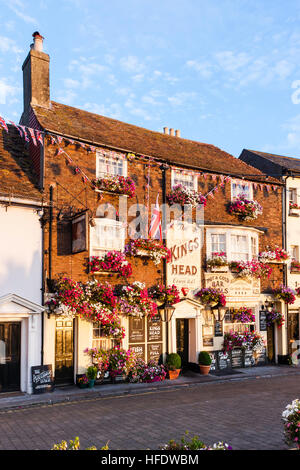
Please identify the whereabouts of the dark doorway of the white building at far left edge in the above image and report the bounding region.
[0,322,21,392]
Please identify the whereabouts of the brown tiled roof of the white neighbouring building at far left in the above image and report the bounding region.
[0,126,42,201]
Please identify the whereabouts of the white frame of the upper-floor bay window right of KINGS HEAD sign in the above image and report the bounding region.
[206,227,259,263]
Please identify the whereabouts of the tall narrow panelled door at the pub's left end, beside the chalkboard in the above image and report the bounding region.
[55,320,74,385]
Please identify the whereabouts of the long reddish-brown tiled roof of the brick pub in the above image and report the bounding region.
[33,101,275,182]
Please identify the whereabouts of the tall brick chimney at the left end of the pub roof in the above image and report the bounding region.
[21,31,50,125]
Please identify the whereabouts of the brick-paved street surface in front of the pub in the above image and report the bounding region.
[0,366,300,450]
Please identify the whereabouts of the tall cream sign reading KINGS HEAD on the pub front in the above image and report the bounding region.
[167,222,202,291]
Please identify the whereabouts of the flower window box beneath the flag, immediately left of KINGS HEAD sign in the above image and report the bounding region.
[125,238,170,265]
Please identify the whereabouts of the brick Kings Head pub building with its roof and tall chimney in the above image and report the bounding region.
[0,33,285,392]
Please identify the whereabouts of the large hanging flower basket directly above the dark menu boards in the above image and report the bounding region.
[114,281,157,317]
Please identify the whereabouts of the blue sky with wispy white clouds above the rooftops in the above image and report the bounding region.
[0,0,300,158]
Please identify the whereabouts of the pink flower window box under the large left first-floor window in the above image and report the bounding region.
[88,251,132,278]
